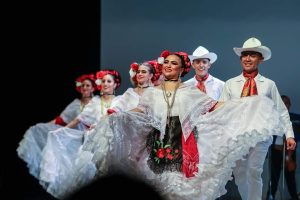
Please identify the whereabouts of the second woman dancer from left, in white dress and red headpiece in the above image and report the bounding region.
[39,70,121,193]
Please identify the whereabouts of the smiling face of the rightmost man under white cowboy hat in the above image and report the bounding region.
[240,51,263,73]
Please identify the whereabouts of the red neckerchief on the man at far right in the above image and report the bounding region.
[241,70,258,97]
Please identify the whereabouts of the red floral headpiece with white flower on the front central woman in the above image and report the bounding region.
[157,50,191,77]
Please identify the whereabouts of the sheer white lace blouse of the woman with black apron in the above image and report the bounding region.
[138,84,216,140]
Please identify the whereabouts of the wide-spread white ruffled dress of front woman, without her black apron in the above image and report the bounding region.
[44,85,284,200]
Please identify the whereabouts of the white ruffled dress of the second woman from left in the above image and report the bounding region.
[38,96,117,196]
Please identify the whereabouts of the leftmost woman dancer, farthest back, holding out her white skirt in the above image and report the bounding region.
[17,74,96,178]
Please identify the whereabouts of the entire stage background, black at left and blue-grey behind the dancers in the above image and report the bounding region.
[0,0,300,200]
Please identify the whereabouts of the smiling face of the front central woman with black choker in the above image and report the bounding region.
[162,55,183,80]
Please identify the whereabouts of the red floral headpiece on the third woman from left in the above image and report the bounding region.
[129,60,162,85]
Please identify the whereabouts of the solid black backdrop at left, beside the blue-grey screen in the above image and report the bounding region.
[0,1,101,199]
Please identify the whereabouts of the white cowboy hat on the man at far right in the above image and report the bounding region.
[233,37,272,61]
